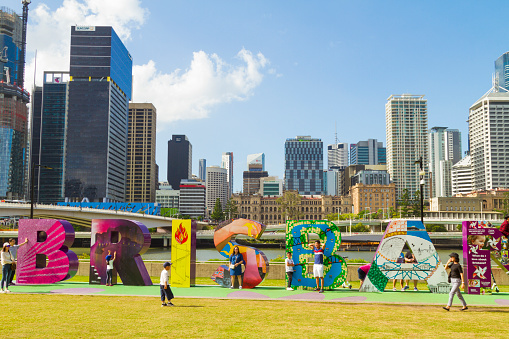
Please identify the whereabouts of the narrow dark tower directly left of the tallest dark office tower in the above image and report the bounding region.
[30,72,69,204]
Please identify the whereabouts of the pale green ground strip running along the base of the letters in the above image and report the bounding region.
[9,282,509,311]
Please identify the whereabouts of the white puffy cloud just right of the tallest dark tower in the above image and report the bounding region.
[133,49,268,123]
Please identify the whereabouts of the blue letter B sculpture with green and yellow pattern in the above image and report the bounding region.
[286,220,348,290]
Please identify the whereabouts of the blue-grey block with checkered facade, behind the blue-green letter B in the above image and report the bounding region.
[284,136,323,195]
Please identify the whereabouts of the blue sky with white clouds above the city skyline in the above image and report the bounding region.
[2,0,509,191]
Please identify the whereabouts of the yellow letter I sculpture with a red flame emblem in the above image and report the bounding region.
[171,220,196,287]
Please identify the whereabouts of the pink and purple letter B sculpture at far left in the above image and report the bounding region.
[16,219,79,284]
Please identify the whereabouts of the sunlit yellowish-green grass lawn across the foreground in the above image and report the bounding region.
[0,294,509,338]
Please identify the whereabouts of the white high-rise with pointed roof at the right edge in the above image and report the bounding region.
[468,84,509,191]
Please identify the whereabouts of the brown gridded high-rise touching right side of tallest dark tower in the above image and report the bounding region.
[126,103,157,202]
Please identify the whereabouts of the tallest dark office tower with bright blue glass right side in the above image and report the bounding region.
[65,26,132,202]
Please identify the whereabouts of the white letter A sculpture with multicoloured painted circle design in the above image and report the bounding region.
[360,220,451,293]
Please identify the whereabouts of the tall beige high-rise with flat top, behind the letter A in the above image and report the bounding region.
[385,94,428,199]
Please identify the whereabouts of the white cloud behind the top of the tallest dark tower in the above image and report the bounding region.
[25,0,148,89]
